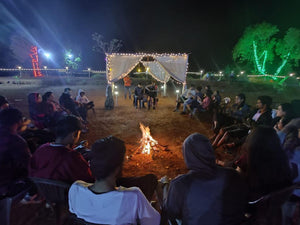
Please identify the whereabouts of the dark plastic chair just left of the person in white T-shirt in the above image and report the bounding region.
[30,177,71,224]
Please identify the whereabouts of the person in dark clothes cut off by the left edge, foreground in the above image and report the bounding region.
[0,108,31,198]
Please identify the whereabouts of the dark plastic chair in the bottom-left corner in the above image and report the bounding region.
[0,188,30,225]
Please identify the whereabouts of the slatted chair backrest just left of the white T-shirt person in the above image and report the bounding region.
[30,177,71,203]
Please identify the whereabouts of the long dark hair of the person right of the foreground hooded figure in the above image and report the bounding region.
[244,126,292,195]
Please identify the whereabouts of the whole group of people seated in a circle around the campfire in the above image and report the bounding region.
[0,76,300,225]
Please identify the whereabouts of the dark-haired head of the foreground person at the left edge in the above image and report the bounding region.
[0,108,23,128]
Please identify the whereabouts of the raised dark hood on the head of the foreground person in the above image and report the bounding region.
[182,133,216,172]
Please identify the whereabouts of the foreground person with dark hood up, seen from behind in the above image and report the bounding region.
[164,133,247,225]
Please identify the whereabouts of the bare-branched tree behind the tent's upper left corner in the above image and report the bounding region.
[92,33,123,54]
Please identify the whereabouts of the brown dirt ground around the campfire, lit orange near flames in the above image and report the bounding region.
[0,75,300,178]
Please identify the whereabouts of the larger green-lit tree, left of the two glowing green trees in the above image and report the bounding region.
[233,23,279,74]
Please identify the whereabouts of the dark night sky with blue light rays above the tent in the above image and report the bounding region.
[0,0,300,71]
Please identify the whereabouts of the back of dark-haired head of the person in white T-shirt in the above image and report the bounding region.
[90,136,126,180]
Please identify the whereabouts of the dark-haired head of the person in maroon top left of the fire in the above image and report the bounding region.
[54,115,82,139]
